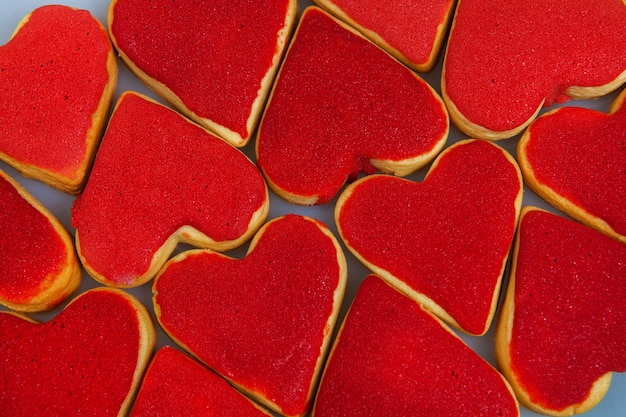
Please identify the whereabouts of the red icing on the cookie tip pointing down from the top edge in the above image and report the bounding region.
[324,0,454,64]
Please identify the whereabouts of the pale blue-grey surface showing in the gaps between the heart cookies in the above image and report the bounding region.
[0,0,626,417]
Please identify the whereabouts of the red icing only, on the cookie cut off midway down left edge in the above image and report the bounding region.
[0,176,68,303]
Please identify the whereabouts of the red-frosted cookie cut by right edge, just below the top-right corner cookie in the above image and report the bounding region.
[517,90,626,243]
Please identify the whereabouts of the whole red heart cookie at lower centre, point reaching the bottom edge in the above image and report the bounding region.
[153,215,347,416]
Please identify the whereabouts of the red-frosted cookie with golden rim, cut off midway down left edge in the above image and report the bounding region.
[0,171,81,312]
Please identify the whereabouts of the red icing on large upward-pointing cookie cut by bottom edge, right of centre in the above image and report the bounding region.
[315,276,519,417]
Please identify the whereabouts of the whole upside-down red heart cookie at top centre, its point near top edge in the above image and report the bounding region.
[256,7,449,205]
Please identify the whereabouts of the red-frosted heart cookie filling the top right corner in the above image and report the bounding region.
[441,0,626,139]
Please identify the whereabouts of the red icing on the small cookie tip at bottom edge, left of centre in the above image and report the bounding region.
[131,346,267,417]
